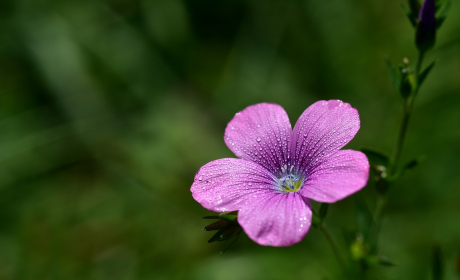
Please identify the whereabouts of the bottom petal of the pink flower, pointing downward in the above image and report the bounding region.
[238,192,312,247]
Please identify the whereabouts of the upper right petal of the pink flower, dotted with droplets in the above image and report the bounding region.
[291,100,360,176]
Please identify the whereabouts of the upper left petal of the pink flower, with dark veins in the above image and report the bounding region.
[224,103,292,174]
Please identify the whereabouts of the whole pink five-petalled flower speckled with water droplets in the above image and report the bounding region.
[190,100,369,247]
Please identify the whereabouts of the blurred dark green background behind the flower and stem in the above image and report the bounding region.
[0,0,460,280]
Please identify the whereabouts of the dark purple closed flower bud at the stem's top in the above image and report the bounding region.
[415,0,436,52]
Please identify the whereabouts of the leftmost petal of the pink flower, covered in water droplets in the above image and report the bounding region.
[190,158,276,212]
